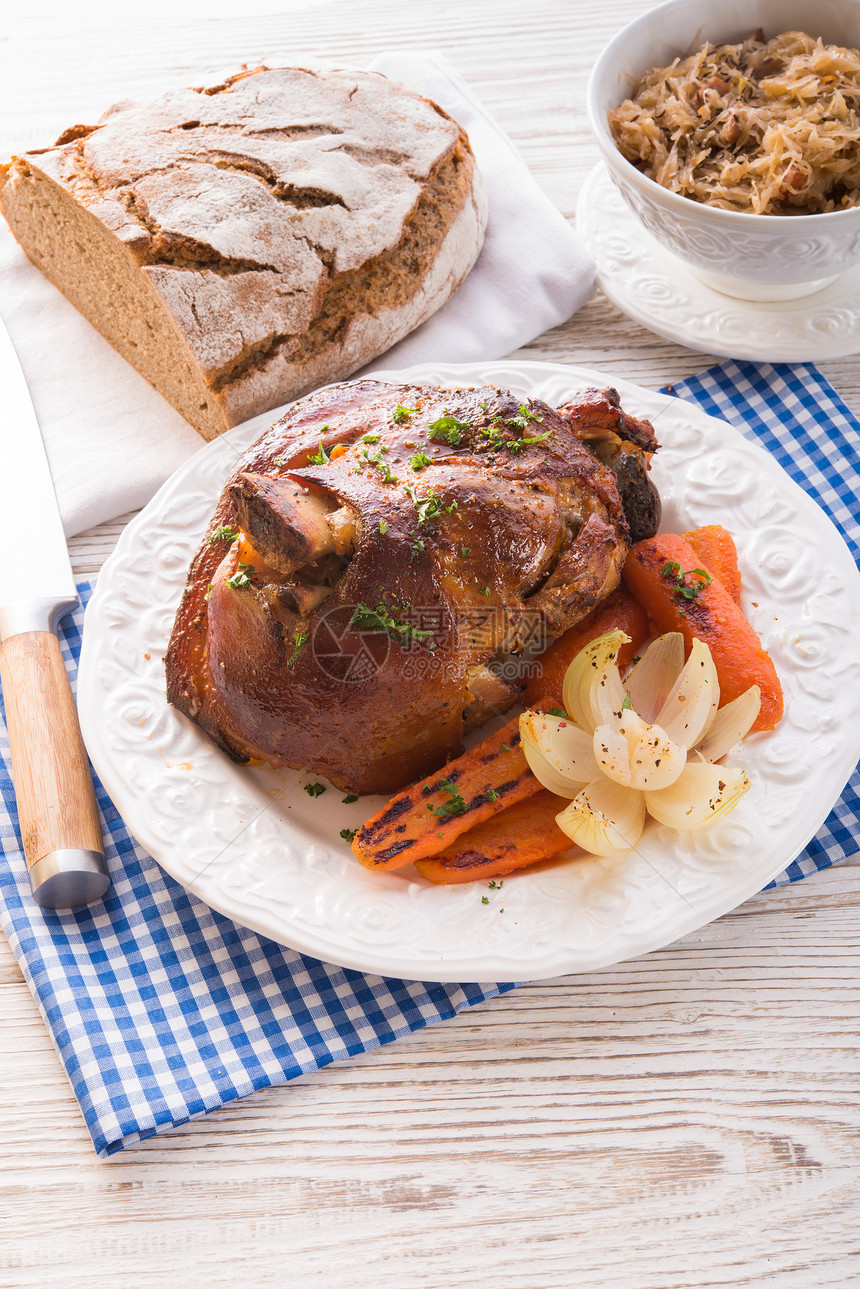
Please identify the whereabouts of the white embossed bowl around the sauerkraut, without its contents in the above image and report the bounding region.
[588,0,860,300]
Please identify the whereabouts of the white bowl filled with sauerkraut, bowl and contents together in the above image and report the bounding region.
[588,0,860,300]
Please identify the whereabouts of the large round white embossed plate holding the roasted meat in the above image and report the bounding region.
[79,362,860,981]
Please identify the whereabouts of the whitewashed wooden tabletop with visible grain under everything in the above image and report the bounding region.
[0,0,860,1289]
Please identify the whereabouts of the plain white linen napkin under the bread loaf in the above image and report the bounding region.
[0,52,594,536]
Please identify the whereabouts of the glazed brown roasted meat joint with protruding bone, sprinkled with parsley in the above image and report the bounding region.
[166,380,659,793]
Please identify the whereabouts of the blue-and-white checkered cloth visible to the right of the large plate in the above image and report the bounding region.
[663,361,860,886]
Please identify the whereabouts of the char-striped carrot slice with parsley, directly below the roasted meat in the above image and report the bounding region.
[352,699,561,869]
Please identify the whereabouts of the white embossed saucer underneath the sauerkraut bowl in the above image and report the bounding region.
[576,164,860,362]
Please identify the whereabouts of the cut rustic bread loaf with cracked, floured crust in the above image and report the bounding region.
[0,67,486,438]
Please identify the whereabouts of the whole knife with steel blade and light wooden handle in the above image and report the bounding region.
[0,321,110,909]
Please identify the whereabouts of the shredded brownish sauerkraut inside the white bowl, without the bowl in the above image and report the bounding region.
[609,27,860,215]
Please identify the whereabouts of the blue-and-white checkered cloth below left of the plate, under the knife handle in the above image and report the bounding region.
[0,613,514,1156]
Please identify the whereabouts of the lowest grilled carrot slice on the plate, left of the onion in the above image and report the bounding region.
[415,788,571,886]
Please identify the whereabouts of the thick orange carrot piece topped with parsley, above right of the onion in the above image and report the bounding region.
[623,532,783,730]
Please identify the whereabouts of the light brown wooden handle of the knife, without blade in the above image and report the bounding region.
[0,632,103,907]
